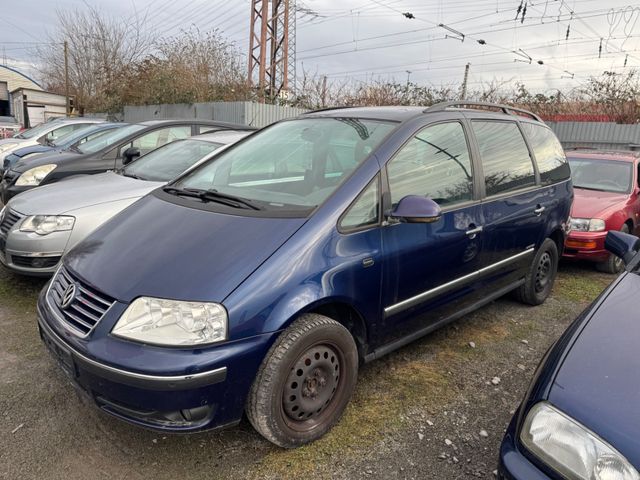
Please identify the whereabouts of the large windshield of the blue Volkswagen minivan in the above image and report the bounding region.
[174,118,395,209]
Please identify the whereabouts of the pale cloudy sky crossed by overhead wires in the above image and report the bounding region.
[0,0,640,93]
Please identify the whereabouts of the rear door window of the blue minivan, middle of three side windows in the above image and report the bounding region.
[472,120,536,196]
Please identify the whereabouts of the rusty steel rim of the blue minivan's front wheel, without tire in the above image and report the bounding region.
[281,343,345,432]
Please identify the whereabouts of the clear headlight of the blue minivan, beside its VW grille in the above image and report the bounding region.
[112,297,227,347]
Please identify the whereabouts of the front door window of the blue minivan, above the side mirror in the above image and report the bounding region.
[387,122,473,206]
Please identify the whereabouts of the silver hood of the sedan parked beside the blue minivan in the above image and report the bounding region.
[9,172,162,215]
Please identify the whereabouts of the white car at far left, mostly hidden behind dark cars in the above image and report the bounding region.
[0,117,104,165]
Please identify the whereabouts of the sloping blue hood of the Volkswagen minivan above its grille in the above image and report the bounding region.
[65,194,306,303]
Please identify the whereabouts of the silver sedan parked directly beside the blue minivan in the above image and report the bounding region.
[0,130,251,275]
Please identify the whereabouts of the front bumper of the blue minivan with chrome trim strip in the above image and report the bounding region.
[38,289,274,432]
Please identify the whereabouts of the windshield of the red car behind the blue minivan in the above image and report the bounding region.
[568,157,633,193]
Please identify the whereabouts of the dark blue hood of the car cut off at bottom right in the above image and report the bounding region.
[549,273,640,469]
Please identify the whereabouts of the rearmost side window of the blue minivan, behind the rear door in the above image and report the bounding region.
[522,123,571,185]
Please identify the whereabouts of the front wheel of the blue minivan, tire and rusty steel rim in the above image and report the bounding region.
[246,314,358,448]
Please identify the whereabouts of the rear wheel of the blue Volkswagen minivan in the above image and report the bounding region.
[515,238,558,305]
